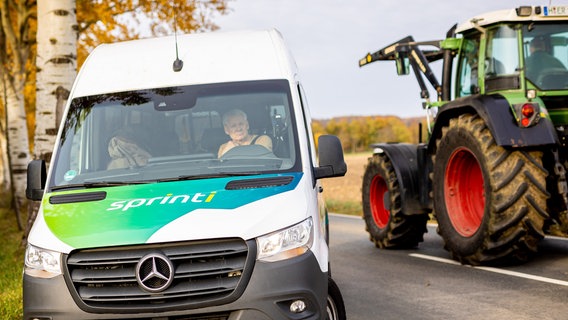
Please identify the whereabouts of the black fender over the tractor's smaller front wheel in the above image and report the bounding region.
[371,143,431,215]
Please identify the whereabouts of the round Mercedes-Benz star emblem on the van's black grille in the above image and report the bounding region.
[136,253,174,293]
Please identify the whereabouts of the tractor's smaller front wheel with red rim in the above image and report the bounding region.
[362,154,428,249]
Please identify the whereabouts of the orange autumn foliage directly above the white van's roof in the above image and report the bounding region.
[76,0,229,66]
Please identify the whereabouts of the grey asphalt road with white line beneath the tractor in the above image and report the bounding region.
[330,215,568,320]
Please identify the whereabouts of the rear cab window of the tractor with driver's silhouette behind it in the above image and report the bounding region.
[523,23,568,90]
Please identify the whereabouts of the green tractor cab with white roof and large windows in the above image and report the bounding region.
[452,6,568,127]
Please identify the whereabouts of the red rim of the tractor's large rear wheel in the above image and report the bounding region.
[444,148,485,237]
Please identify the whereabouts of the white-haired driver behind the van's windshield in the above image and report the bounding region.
[218,109,272,157]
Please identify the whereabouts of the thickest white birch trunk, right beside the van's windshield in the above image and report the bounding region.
[34,0,78,163]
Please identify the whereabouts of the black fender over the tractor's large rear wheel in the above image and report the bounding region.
[428,94,559,151]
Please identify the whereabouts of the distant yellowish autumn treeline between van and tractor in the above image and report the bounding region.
[312,116,427,152]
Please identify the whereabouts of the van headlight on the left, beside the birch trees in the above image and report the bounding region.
[24,244,61,278]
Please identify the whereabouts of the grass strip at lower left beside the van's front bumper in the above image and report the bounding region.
[0,208,24,319]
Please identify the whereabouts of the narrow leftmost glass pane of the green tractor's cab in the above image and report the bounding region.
[456,35,479,97]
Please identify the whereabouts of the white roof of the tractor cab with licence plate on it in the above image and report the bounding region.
[456,6,568,33]
